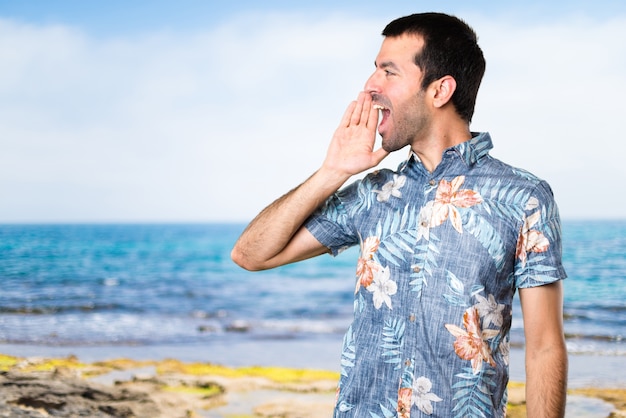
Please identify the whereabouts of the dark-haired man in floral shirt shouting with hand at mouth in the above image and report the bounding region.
[232,13,567,418]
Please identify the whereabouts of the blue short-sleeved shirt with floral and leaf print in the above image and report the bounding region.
[306,133,566,418]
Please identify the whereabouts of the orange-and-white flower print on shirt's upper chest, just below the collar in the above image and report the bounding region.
[430,176,483,233]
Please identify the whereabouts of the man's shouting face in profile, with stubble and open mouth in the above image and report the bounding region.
[365,35,430,152]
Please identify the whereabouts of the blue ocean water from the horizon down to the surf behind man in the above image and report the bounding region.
[0,221,626,356]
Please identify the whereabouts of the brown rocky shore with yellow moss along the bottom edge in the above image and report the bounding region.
[0,355,626,418]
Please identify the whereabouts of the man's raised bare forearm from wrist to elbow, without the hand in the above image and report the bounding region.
[231,168,348,270]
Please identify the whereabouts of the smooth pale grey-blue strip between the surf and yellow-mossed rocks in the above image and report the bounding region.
[0,336,626,388]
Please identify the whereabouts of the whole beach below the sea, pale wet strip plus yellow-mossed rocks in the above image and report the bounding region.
[0,338,626,418]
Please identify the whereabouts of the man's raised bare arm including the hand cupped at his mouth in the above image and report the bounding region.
[231,92,388,270]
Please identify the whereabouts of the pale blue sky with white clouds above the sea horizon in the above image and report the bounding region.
[0,0,626,222]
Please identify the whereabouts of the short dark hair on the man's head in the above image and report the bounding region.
[382,13,485,122]
